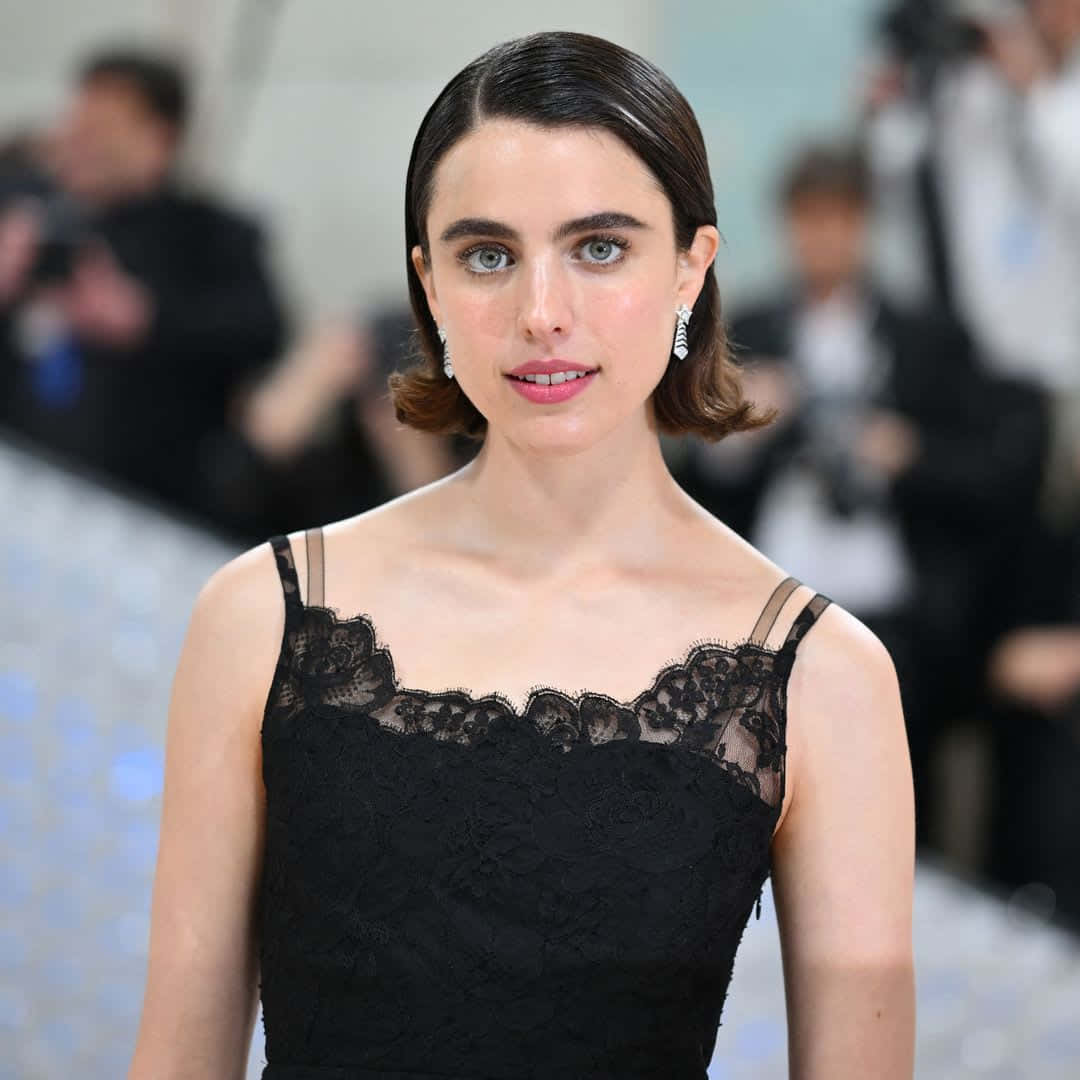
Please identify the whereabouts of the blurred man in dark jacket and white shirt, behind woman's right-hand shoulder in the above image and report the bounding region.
[680,145,1044,843]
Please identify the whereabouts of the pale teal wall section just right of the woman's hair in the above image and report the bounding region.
[665,0,886,299]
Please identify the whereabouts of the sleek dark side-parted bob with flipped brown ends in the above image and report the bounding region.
[389,32,775,442]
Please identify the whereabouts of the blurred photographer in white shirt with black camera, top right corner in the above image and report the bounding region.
[867,0,1080,518]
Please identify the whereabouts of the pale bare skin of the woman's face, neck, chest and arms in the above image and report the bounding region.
[130,120,915,1080]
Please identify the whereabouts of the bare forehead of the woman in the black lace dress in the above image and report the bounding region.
[429,119,669,231]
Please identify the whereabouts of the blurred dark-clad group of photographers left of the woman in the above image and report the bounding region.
[0,49,473,542]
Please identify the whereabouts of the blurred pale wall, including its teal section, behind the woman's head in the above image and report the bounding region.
[0,0,879,318]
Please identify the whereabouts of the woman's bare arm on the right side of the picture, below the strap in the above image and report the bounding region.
[773,604,915,1080]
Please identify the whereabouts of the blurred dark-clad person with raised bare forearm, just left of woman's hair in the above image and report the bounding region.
[204,307,475,543]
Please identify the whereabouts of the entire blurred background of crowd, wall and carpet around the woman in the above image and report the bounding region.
[0,0,1080,1080]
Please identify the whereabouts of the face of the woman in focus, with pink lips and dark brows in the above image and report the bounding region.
[411,119,718,453]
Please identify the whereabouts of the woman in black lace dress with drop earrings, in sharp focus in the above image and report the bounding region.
[131,33,914,1080]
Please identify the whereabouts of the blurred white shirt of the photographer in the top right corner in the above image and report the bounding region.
[935,0,1080,390]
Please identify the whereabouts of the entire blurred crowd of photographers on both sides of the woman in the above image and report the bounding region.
[0,0,1080,927]
